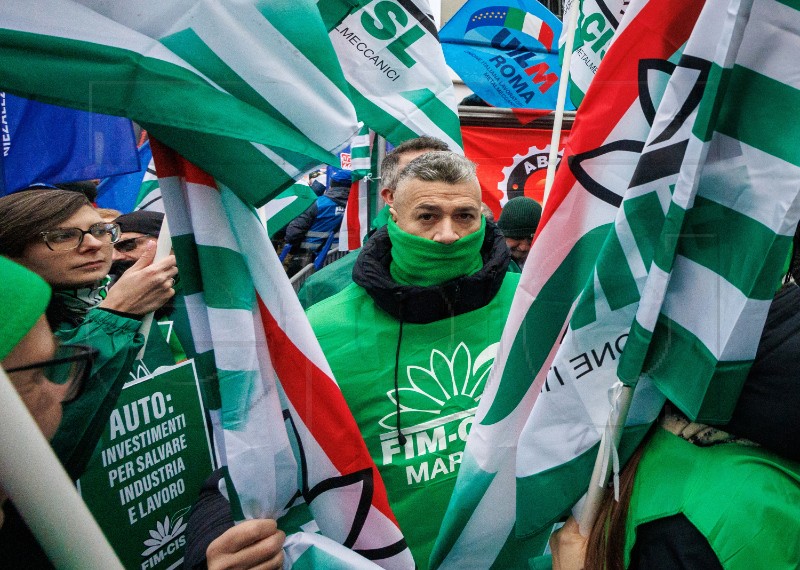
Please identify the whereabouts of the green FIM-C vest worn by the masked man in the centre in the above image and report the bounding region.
[308,273,519,568]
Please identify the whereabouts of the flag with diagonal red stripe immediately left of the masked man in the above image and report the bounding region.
[152,141,413,569]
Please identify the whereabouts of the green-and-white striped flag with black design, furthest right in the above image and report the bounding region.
[517,0,800,532]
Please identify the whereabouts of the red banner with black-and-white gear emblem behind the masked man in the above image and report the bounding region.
[461,127,569,219]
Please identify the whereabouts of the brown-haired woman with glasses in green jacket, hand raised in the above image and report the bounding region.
[0,189,177,479]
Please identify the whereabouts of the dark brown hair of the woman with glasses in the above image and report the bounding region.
[0,188,92,258]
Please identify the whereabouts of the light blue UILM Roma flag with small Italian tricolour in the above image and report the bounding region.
[439,0,574,110]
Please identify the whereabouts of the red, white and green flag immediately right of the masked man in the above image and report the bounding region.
[432,0,700,568]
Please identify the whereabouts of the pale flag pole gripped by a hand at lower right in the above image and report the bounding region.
[578,385,635,537]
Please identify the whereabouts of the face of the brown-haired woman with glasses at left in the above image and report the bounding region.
[16,206,113,289]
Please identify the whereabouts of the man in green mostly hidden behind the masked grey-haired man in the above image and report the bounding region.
[297,135,450,309]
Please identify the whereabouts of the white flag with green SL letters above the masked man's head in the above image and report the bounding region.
[320,0,461,151]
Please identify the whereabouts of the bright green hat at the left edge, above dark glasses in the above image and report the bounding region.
[0,256,50,360]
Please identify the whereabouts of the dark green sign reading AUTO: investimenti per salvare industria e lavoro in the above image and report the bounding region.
[79,360,214,569]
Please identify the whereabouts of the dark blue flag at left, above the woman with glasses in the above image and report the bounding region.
[0,93,139,195]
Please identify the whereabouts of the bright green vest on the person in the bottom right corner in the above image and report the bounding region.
[625,429,800,570]
